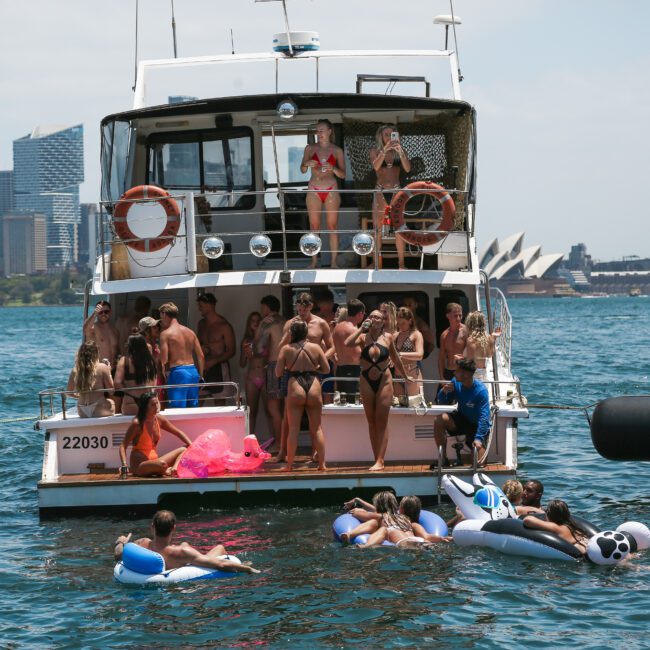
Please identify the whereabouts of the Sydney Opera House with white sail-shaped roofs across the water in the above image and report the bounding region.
[479,232,571,295]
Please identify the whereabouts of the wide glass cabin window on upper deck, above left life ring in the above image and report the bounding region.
[148,128,254,209]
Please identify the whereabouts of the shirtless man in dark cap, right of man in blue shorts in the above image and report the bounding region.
[196,293,235,399]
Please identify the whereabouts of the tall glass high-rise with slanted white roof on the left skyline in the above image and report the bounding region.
[14,124,84,269]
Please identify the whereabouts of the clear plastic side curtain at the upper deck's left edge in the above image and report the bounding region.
[101,120,135,201]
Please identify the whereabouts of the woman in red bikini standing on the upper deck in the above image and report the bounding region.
[300,120,345,269]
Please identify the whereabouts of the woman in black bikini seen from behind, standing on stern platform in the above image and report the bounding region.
[275,319,330,472]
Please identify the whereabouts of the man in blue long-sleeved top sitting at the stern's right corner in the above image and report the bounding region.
[431,359,490,468]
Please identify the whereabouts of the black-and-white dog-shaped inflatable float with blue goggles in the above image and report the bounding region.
[442,473,650,564]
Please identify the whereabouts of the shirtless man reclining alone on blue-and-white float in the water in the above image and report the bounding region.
[113,510,260,573]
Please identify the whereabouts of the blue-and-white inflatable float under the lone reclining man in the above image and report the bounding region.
[113,542,241,585]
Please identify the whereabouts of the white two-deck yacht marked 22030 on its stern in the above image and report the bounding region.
[37,21,528,515]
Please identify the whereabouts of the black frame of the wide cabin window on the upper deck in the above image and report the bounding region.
[145,126,257,212]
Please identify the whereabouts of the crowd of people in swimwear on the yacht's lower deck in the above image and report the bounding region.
[68,289,499,476]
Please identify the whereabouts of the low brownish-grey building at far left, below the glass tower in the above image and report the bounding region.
[0,212,47,276]
